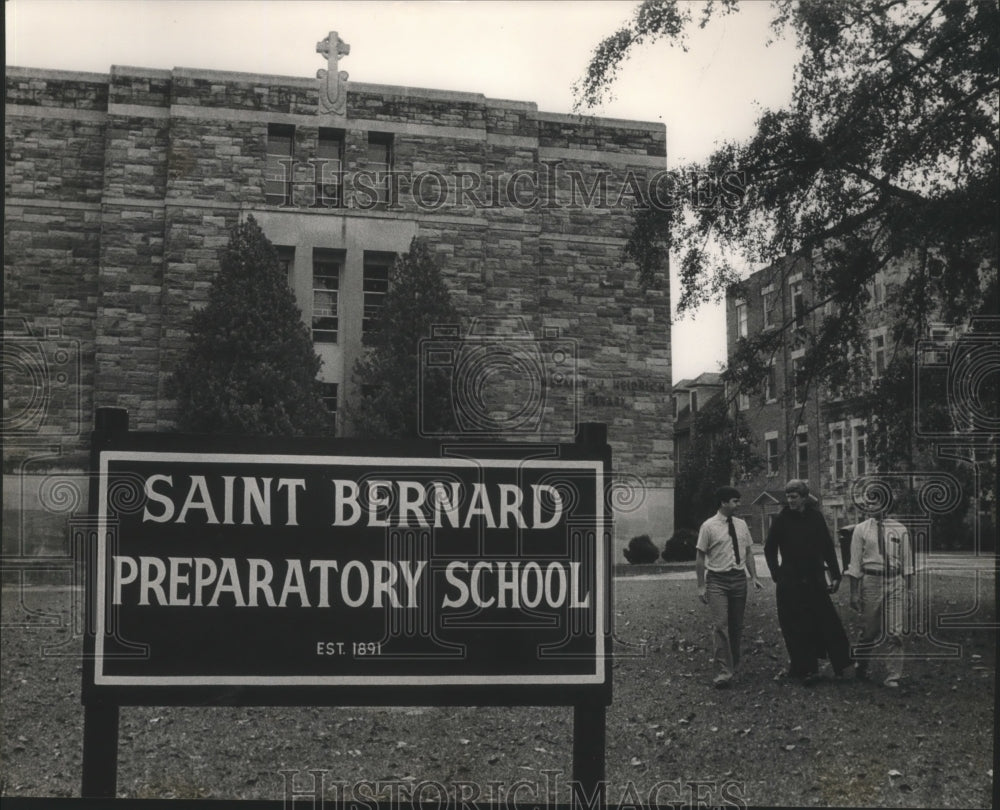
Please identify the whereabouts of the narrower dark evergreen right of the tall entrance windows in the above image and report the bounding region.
[347,237,459,438]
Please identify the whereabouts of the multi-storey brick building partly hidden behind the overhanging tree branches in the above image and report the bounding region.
[726,254,972,542]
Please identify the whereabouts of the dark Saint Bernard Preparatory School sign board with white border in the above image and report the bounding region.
[85,433,610,703]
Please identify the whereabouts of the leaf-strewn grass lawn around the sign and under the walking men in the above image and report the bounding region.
[0,575,996,808]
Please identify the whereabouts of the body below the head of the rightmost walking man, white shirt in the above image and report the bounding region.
[846,511,914,688]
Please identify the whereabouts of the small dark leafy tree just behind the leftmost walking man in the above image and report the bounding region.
[674,396,762,529]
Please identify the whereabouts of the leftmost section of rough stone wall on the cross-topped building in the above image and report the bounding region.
[3,70,107,467]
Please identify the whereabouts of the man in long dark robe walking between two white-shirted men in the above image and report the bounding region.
[764,479,851,683]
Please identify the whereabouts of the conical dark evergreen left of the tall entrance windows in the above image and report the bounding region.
[173,216,333,436]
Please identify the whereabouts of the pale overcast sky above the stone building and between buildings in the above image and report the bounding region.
[5,0,795,381]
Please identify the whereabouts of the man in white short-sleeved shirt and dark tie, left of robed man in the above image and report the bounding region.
[695,487,762,689]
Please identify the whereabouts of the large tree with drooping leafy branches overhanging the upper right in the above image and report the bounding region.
[576,0,1000,400]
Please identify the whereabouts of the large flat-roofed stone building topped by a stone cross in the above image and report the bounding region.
[4,44,673,557]
